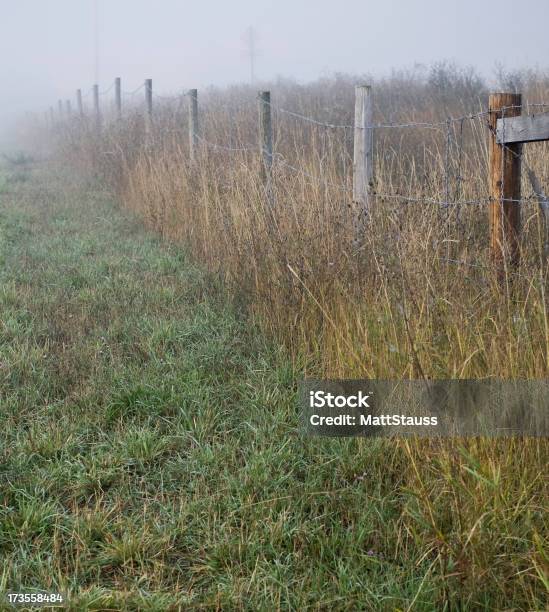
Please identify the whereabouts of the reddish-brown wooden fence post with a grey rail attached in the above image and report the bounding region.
[488,93,522,266]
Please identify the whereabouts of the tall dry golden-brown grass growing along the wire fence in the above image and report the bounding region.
[48,67,549,603]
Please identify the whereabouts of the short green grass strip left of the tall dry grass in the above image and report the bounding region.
[0,168,544,611]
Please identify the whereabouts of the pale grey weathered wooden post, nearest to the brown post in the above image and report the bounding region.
[353,85,374,233]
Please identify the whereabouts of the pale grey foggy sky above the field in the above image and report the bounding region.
[0,0,549,121]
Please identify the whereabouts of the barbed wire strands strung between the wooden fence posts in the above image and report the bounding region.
[46,79,549,284]
